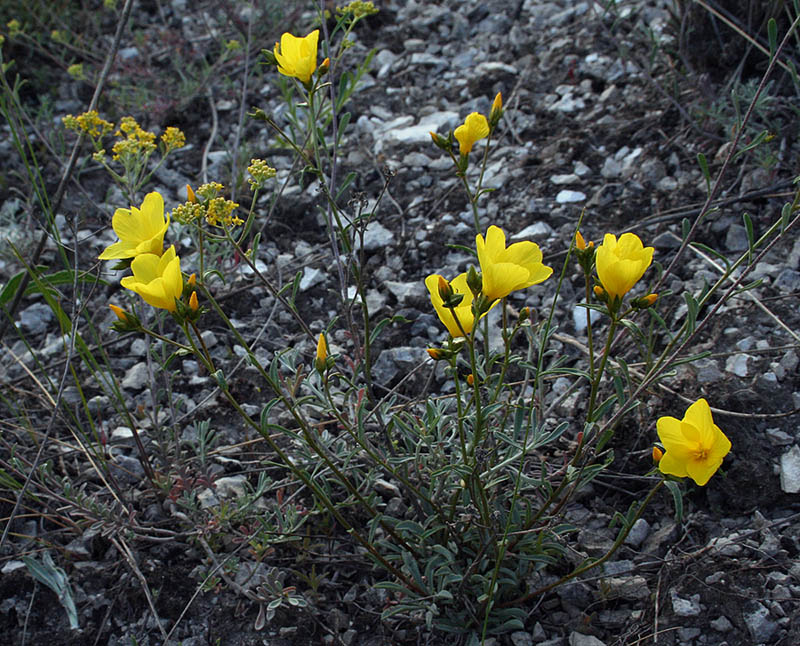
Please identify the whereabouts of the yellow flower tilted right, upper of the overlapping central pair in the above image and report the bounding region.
[475,226,553,300]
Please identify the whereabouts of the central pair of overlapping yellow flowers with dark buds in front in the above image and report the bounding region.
[425,226,553,338]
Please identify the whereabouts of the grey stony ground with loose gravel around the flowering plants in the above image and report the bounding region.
[0,0,800,646]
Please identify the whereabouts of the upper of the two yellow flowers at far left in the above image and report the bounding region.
[99,191,169,260]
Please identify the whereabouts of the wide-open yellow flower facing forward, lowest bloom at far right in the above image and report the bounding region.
[657,399,731,486]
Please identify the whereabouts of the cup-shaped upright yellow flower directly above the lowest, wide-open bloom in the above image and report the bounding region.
[595,233,653,299]
